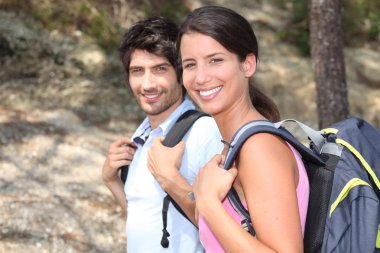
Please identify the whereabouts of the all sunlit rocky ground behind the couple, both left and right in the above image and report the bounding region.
[0,1,380,253]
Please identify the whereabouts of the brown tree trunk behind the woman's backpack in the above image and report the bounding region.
[309,0,349,128]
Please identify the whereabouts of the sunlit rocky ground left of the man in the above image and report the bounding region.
[0,9,142,253]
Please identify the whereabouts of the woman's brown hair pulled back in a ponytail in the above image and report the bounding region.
[177,6,280,122]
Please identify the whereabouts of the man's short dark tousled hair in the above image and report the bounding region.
[119,17,182,85]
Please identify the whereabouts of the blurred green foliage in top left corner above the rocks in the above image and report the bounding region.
[0,0,120,51]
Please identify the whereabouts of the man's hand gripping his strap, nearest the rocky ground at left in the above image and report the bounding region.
[102,137,136,183]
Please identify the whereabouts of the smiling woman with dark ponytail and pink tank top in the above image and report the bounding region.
[149,6,309,253]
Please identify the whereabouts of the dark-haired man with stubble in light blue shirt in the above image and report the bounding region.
[103,17,223,253]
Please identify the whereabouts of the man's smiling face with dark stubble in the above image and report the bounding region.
[128,49,182,116]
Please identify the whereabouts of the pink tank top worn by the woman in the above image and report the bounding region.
[198,144,309,253]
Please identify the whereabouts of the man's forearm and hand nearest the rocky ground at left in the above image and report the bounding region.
[102,138,136,212]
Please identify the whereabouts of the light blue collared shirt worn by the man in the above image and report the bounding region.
[124,99,223,253]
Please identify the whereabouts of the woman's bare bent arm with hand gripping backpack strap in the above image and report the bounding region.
[194,134,303,253]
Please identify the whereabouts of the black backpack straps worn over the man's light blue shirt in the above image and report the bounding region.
[120,110,209,248]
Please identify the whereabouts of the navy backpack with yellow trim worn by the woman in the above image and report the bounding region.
[224,117,380,253]
